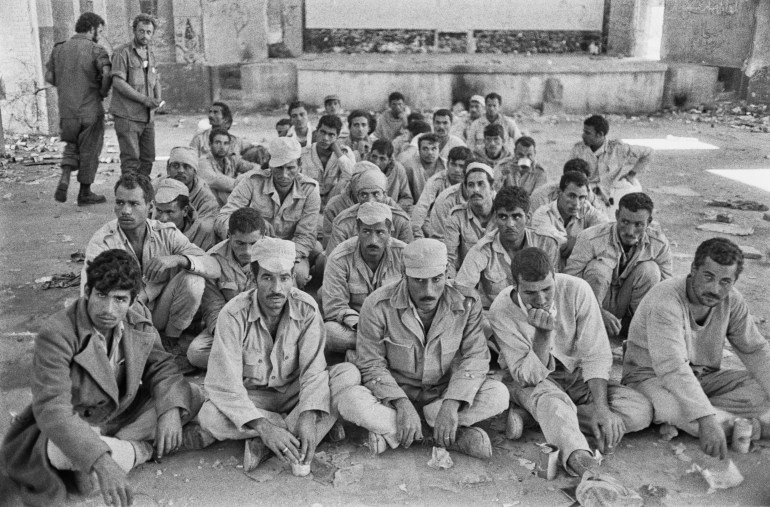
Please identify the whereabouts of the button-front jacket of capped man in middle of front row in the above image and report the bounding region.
[356,278,489,404]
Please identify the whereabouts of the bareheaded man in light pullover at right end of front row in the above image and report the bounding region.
[623,238,770,459]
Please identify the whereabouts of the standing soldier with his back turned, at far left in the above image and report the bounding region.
[45,12,111,206]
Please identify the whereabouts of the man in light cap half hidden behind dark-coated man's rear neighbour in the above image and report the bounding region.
[155,178,216,250]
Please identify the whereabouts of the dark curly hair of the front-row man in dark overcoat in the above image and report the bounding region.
[86,249,142,302]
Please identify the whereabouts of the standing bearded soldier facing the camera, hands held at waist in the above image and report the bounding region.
[110,14,162,177]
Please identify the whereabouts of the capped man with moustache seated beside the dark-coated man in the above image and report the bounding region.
[199,238,361,472]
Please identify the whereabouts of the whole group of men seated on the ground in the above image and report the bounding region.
[0,93,770,505]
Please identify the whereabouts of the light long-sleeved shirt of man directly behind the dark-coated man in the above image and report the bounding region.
[80,219,220,303]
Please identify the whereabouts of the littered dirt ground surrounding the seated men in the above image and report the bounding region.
[0,109,770,506]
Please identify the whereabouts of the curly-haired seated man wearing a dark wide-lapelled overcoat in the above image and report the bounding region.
[0,250,203,506]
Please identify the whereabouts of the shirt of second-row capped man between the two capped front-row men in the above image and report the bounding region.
[321,237,406,324]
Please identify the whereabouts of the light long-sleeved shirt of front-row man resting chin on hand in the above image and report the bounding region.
[489,273,612,387]
